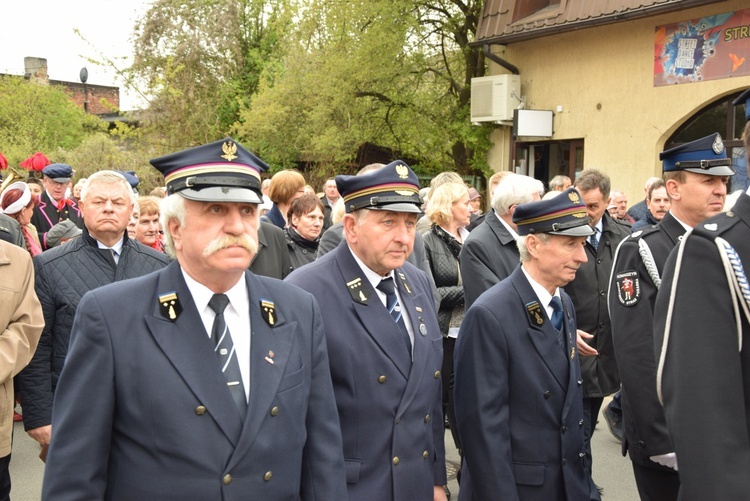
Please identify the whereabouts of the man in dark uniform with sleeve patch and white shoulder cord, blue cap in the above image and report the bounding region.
[608,134,734,501]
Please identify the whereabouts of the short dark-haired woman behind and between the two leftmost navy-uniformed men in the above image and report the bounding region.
[284,195,324,270]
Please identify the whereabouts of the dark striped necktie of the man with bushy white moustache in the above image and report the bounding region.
[208,294,247,420]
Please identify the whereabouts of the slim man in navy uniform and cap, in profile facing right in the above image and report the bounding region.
[454,188,593,501]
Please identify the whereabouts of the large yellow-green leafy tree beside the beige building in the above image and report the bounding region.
[237,0,489,174]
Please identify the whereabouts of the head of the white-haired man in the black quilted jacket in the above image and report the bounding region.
[79,180,133,244]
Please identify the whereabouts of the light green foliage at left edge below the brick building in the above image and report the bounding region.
[0,76,106,166]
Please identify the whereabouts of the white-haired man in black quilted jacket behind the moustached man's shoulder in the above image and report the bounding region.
[19,171,169,445]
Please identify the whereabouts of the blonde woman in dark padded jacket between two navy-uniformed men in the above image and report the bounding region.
[424,182,474,449]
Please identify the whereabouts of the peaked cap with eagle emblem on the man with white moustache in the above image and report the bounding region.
[151,137,269,204]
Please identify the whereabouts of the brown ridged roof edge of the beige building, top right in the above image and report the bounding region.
[474,0,721,44]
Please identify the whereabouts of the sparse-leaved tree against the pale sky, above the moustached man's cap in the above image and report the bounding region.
[129,0,292,151]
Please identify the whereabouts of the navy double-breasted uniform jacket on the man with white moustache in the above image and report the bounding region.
[42,262,346,500]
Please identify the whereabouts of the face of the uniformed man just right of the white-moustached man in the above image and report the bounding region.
[344,210,417,275]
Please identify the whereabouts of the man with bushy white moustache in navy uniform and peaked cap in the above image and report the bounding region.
[42,138,346,500]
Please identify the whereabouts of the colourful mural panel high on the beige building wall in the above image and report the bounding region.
[654,9,750,87]
